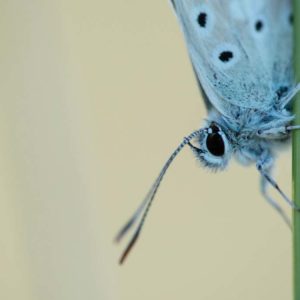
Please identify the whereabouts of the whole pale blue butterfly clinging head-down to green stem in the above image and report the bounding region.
[116,0,300,263]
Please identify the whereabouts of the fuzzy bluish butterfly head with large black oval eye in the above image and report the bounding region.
[189,122,232,170]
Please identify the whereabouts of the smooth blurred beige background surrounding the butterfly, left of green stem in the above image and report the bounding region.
[0,0,291,300]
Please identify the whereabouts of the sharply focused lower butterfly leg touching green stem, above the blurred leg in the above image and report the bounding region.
[256,157,300,211]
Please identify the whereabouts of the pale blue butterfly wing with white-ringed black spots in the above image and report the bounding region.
[172,0,293,116]
